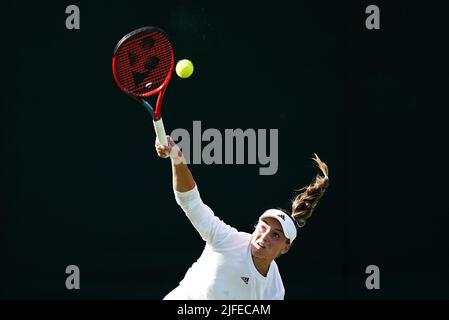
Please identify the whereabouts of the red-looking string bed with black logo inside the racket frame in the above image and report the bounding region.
[116,32,173,95]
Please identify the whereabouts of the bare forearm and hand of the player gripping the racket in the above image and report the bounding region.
[156,136,195,192]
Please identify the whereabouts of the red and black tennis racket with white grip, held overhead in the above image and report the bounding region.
[112,27,174,146]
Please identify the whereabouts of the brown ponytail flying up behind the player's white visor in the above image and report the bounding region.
[291,153,329,228]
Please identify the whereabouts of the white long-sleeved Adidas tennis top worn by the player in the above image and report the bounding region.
[164,186,285,300]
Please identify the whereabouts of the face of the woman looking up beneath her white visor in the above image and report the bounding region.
[251,218,290,260]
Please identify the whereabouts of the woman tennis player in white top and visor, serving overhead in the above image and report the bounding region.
[156,136,329,300]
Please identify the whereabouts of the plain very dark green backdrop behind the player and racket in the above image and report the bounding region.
[0,1,449,300]
